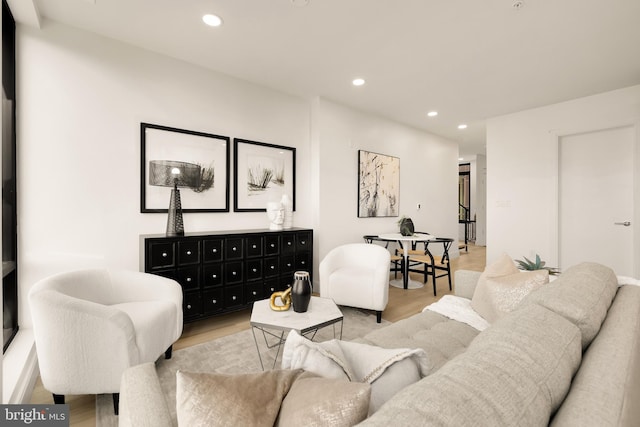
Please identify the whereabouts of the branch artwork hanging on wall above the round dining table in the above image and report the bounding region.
[358,150,400,218]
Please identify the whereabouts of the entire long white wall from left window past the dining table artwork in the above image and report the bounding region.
[17,21,458,320]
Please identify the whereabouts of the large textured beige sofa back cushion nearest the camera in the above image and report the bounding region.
[361,306,581,426]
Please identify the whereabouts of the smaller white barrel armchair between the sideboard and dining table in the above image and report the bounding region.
[320,243,391,323]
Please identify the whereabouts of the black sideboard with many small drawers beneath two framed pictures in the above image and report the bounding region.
[140,228,313,323]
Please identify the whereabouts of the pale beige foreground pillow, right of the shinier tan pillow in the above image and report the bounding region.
[276,373,371,427]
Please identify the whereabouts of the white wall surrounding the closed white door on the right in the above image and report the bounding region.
[487,86,640,272]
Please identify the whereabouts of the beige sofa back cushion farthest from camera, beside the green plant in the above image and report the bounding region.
[521,262,618,350]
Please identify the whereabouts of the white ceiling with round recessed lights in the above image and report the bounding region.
[9,0,640,155]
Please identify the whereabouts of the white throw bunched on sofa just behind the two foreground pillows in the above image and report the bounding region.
[282,330,433,414]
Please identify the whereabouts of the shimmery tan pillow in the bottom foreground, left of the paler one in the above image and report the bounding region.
[176,370,303,427]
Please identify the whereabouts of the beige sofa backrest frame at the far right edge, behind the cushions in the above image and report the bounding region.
[552,286,640,426]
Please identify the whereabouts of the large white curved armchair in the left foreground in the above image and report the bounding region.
[29,269,182,414]
